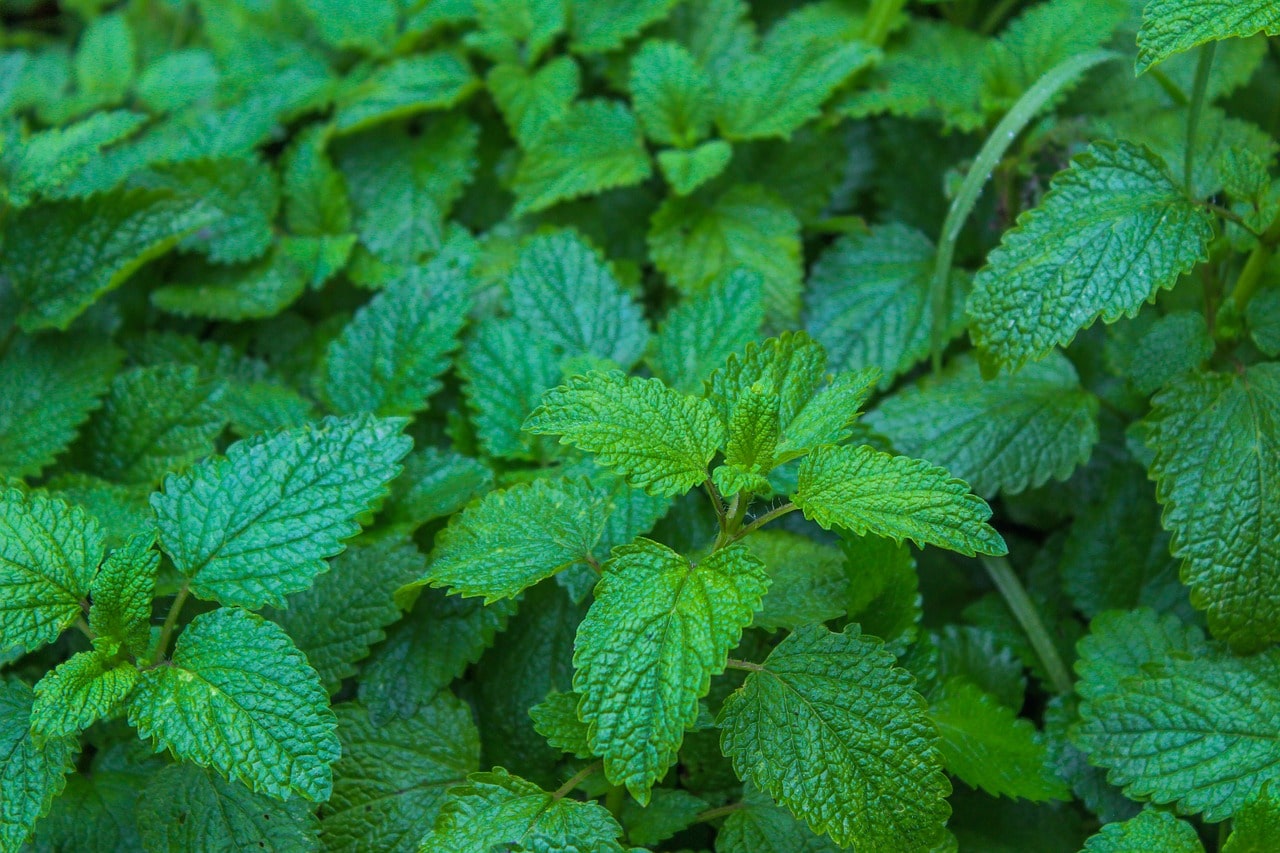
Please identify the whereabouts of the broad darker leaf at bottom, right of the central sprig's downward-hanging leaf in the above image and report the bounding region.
[717,625,951,852]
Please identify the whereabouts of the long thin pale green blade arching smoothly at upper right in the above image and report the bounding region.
[929,50,1116,373]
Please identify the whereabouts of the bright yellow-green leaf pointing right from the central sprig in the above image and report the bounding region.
[792,446,1007,556]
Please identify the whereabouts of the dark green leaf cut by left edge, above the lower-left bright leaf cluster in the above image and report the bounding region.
[0,334,120,478]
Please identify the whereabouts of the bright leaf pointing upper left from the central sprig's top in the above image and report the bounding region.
[525,371,724,496]
